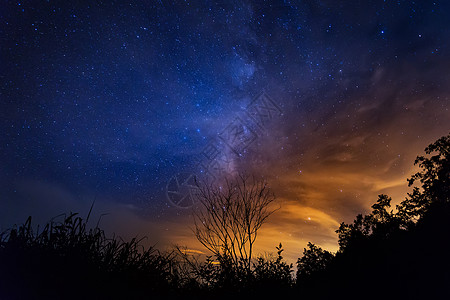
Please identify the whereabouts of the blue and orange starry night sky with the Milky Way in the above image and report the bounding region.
[0,0,450,262]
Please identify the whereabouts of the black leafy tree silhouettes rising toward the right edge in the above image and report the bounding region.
[321,135,450,299]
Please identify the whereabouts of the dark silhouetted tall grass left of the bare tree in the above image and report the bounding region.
[0,209,175,299]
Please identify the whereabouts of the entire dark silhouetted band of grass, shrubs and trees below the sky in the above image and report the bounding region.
[0,135,450,299]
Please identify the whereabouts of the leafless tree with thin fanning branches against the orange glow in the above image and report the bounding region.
[194,175,277,271]
